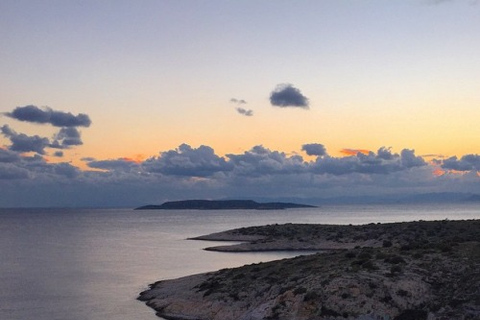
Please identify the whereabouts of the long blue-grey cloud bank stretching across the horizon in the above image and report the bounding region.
[0,134,480,206]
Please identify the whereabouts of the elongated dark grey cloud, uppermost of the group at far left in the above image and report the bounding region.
[6,105,92,127]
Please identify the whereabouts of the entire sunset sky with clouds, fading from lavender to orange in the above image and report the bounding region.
[0,0,480,207]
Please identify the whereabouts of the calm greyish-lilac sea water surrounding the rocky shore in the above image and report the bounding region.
[0,204,480,320]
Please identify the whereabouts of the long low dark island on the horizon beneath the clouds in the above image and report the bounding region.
[135,200,316,210]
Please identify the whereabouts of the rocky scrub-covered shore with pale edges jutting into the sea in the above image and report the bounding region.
[139,220,480,320]
